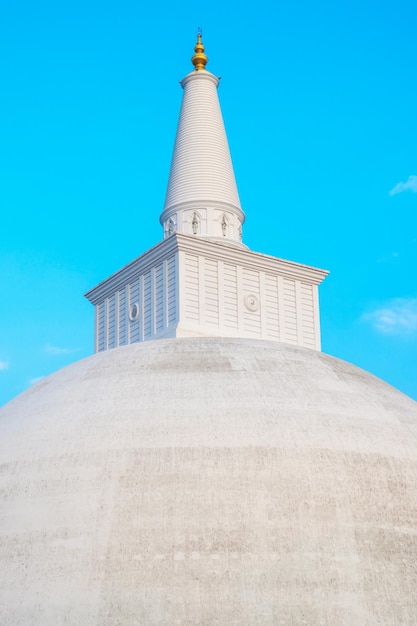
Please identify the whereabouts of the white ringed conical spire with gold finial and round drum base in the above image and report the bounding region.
[160,33,245,243]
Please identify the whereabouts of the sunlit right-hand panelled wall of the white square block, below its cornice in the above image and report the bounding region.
[178,247,320,350]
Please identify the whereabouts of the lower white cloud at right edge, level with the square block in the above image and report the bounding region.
[363,298,417,335]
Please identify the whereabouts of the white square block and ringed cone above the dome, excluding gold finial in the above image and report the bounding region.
[86,48,327,352]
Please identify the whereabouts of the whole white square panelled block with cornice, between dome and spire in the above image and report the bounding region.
[86,233,327,352]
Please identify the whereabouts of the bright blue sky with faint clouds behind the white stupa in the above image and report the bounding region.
[0,0,417,404]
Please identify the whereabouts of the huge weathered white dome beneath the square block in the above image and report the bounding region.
[0,338,417,626]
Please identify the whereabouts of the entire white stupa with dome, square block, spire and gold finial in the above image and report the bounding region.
[0,35,417,626]
